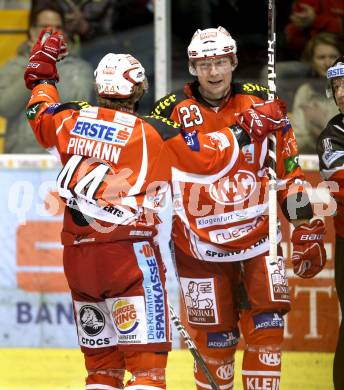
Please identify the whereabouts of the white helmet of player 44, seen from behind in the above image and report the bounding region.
[94,53,147,99]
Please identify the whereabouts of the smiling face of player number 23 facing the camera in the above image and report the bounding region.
[194,57,234,100]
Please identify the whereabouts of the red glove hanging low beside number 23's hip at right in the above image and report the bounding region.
[291,219,326,278]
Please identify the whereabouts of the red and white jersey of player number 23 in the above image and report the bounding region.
[153,84,304,262]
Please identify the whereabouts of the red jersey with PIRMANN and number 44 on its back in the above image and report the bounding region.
[27,84,243,239]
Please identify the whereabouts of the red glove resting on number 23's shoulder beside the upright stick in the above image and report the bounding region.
[236,99,288,142]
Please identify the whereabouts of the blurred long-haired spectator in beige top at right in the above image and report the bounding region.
[291,32,344,154]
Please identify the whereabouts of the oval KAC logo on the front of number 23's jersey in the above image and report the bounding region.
[209,170,257,205]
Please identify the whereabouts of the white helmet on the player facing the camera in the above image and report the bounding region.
[188,26,238,76]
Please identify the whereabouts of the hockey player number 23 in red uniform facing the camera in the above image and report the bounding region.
[152,27,326,390]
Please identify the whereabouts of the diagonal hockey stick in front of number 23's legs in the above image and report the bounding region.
[169,304,220,390]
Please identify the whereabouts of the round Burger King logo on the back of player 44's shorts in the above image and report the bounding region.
[112,299,139,334]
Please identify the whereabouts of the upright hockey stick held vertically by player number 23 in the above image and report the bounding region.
[268,0,277,264]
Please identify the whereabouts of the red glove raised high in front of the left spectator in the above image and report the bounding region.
[24,28,68,89]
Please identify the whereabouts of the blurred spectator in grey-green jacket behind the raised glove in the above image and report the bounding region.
[0,1,93,153]
